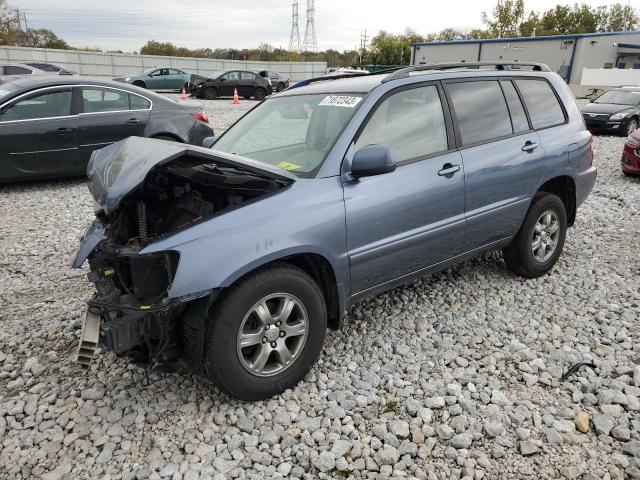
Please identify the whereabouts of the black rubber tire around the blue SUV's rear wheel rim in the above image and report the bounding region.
[502,192,567,278]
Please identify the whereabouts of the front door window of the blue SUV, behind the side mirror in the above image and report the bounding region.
[356,85,448,162]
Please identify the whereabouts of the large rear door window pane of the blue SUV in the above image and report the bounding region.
[447,80,513,146]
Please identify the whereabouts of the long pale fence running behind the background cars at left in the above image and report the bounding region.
[0,46,327,81]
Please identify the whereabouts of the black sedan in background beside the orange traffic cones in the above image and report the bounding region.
[189,70,273,100]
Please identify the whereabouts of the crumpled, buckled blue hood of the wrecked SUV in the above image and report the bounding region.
[87,137,296,215]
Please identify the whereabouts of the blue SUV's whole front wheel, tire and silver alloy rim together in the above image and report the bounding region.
[204,263,327,401]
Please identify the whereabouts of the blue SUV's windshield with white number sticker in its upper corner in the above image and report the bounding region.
[213,94,362,177]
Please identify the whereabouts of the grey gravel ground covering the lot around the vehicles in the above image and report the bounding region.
[0,96,640,480]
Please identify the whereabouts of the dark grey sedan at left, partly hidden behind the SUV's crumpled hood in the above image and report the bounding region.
[0,75,213,182]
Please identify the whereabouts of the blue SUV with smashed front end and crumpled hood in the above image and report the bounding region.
[73,62,596,400]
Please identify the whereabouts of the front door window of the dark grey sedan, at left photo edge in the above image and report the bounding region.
[0,90,71,122]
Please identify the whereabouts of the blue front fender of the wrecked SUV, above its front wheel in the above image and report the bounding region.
[140,177,349,298]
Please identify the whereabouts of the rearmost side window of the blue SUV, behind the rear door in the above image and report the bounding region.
[516,79,565,129]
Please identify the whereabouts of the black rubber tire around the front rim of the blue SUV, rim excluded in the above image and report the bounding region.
[203,263,327,401]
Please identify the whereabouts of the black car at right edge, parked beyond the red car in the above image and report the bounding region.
[581,87,640,135]
